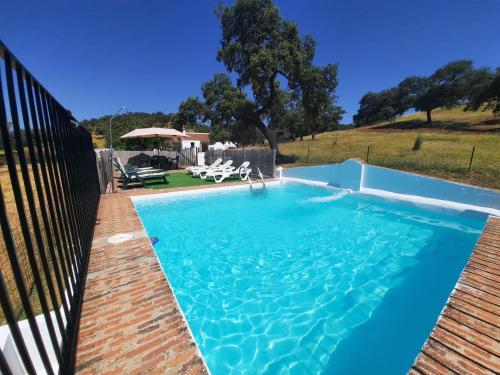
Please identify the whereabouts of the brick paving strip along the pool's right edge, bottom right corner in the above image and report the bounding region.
[409,217,500,374]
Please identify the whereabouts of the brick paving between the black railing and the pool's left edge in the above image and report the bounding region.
[75,182,266,375]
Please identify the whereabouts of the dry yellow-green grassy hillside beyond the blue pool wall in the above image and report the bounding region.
[280,108,500,189]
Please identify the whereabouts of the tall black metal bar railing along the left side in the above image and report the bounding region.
[0,41,100,374]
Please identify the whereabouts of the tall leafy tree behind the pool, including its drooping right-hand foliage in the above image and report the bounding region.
[216,0,340,149]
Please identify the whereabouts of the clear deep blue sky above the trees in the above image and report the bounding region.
[0,0,500,122]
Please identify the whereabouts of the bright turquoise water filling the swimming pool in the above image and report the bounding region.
[135,184,485,375]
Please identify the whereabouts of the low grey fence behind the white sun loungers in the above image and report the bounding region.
[205,148,276,177]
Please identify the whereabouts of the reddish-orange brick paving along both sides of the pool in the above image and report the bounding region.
[76,183,500,374]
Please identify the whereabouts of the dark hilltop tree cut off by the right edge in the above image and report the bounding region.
[464,67,500,114]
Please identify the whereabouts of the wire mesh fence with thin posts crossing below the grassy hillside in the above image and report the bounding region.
[283,136,500,189]
